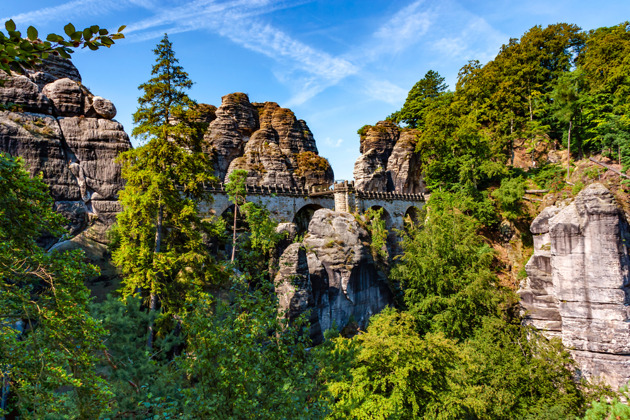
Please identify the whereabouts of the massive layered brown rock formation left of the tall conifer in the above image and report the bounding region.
[0,58,131,241]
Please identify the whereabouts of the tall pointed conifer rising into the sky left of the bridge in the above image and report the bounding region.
[114,35,213,348]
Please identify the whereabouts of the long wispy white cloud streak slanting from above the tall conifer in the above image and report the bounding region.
[127,0,359,105]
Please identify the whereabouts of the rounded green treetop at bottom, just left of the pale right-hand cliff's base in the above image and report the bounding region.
[451,318,584,419]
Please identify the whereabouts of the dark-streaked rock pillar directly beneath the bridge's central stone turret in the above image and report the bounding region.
[275,209,393,343]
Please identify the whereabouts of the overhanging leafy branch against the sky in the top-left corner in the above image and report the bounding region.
[0,20,125,74]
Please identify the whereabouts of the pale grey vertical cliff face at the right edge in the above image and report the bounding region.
[520,184,630,387]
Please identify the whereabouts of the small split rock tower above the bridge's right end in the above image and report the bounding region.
[354,121,424,194]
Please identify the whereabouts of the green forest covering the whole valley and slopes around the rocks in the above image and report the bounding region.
[0,18,630,419]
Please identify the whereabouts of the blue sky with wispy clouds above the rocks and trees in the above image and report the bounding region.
[0,0,630,179]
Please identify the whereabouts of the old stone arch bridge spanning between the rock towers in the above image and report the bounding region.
[201,181,425,231]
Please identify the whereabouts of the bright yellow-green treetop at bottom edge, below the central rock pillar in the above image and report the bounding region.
[318,308,459,419]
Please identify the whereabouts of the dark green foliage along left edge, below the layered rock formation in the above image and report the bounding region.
[0,153,110,419]
